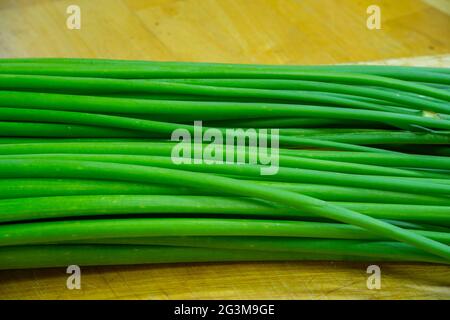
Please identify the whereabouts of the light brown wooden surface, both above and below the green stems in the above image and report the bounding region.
[0,0,450,299]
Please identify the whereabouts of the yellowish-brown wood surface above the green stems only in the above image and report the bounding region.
[0,0,450,64]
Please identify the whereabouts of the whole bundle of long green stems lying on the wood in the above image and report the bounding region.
[0,59,450,269]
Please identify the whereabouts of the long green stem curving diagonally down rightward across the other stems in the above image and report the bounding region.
[0,160,450,260]
